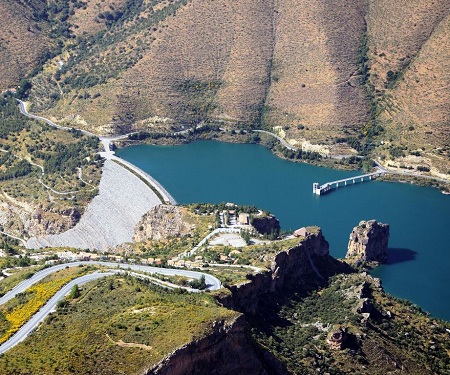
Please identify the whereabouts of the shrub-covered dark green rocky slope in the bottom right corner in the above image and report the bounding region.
[251,274,450,374]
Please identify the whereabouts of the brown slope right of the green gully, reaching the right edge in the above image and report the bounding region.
[368,0,450,171]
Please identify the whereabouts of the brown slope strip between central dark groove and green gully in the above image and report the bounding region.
[265,1,367,142]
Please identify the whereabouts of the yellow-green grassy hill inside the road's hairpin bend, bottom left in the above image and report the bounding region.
[0,276,238,375]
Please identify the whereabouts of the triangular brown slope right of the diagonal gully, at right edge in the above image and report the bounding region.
[383,15,450,148]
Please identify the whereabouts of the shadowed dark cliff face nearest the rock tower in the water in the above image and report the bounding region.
[220,228,332,315]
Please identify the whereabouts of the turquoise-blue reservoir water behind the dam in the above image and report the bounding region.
[117,141,450,320]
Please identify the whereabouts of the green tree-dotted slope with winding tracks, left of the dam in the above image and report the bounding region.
[0,97,102,236]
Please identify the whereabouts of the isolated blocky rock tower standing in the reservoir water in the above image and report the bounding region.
[345,220,389,264]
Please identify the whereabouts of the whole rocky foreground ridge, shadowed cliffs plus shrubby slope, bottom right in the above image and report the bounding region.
[147,226,450,375]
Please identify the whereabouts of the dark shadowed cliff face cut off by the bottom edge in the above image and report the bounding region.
[148,316,288,375]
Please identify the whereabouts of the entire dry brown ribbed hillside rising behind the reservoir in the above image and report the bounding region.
[0,0,450,173]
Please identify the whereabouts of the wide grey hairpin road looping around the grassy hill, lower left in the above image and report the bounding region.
[0,261,222,354]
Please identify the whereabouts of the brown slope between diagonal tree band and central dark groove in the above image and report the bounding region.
[120,0,273,132]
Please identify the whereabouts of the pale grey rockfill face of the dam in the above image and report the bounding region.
[27,160,161,251]
